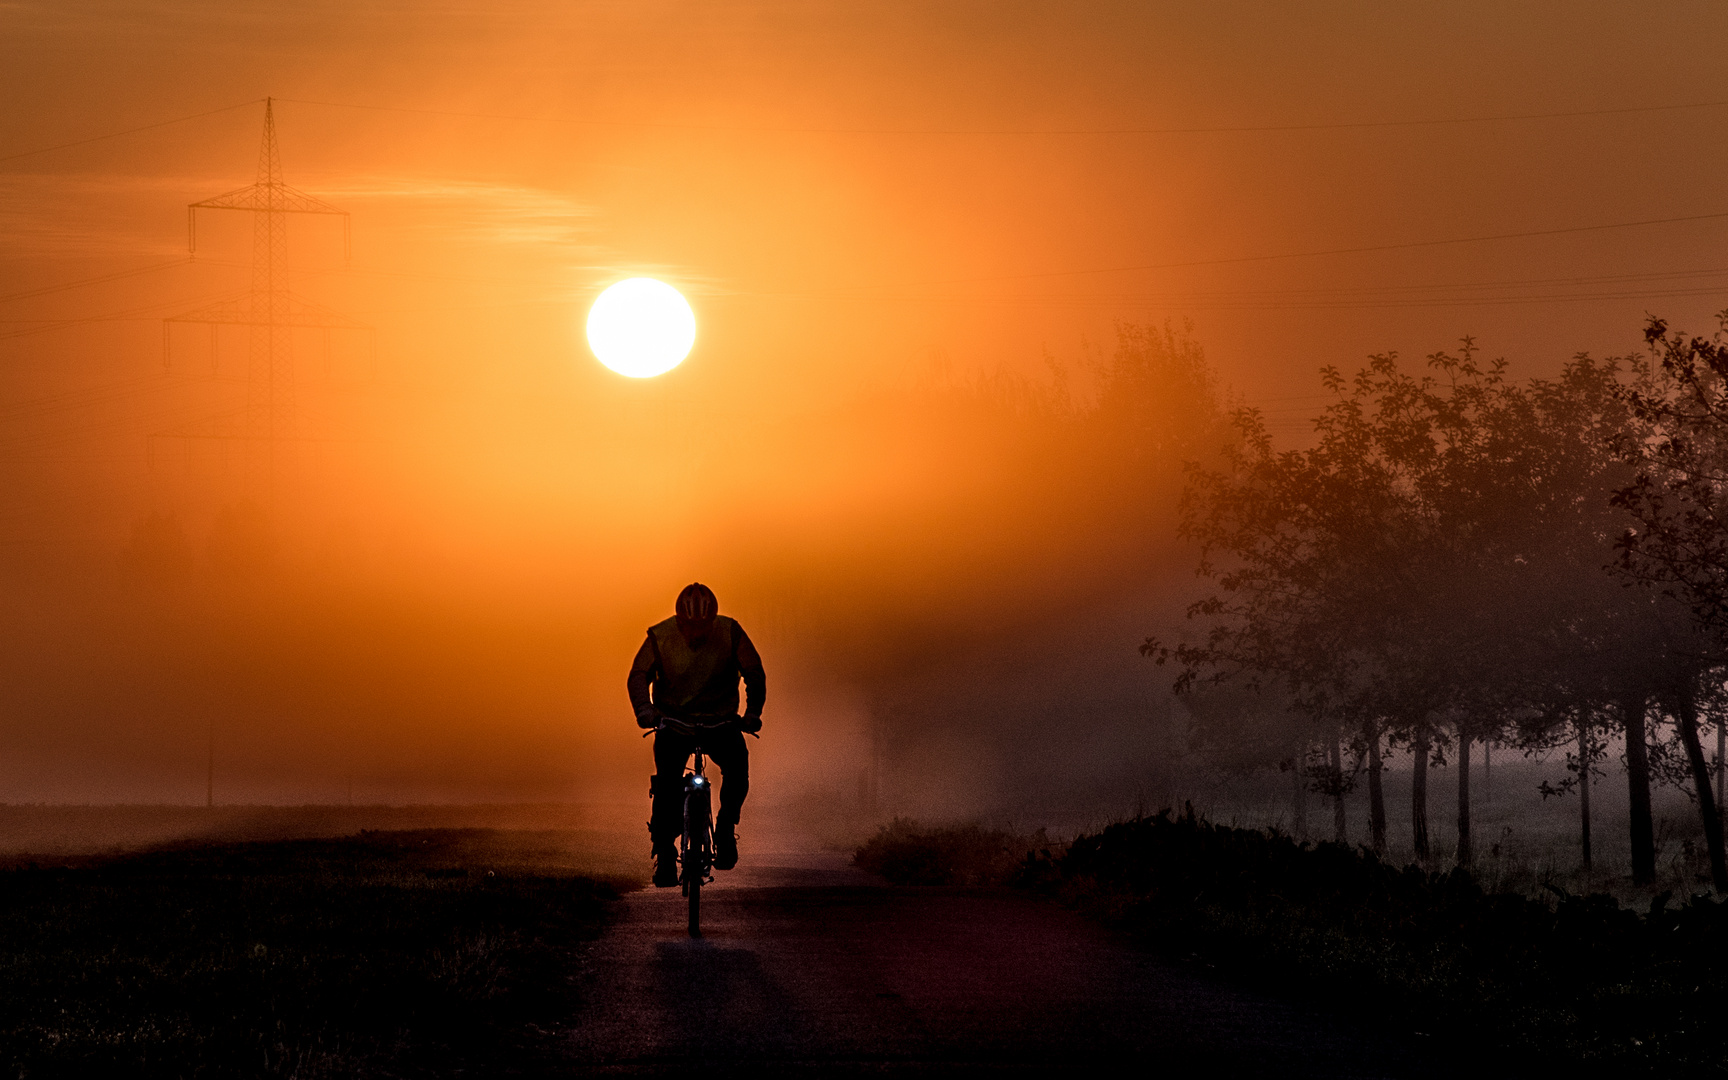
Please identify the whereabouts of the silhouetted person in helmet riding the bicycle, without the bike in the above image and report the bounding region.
[629,582,767,886]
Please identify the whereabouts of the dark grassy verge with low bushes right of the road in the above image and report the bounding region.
[857,812,1728,1077]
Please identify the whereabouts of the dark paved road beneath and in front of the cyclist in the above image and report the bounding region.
[569,852,1424,1080]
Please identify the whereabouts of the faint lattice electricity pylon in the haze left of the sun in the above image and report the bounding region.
[162,98,368,482]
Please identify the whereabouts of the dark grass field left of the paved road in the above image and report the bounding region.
[0,829,615,1077]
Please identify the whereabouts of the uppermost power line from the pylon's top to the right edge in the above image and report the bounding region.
[276,97,1728,135]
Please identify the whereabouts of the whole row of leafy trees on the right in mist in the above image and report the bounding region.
[1142,311,1728,893]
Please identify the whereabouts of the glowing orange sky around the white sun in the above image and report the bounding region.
[0,2,1728,800]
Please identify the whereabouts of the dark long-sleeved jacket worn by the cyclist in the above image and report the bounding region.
[629,615,767,717]
